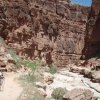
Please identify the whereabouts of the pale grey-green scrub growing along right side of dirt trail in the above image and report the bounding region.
[18,73,45,100]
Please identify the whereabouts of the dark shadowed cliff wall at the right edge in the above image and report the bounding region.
[83,0,100,59]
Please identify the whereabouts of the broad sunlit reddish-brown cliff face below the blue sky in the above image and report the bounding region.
[0,0,89,66]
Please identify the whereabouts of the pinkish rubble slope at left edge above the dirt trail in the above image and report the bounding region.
[0,37,17,72]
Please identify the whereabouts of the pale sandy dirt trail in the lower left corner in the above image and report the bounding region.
[0,73,22,100]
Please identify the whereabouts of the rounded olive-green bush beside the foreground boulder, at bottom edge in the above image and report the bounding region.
[51,87,67,100]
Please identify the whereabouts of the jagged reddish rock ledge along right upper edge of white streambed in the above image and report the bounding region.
[69,65,100,83]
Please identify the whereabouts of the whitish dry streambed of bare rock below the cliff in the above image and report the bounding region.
[55,70,100,98]
